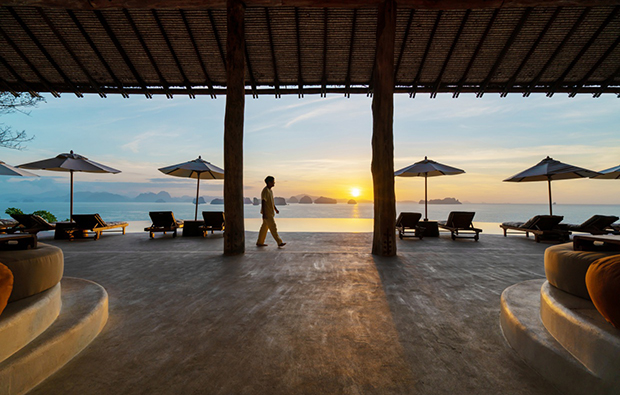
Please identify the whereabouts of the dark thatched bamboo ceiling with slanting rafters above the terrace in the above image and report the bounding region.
[0,0,620,97]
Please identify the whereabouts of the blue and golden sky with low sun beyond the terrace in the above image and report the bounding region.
[0,94,620,204]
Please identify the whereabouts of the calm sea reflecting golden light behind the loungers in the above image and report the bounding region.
[0,201,620,234]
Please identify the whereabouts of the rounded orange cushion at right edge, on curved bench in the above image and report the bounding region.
[586,255,620,329]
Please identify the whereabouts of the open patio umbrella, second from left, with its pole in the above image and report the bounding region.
[17,151,121,221]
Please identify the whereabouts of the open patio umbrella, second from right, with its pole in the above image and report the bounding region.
[504,156,600,215]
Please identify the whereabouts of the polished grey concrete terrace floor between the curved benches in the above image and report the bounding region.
[31,232,557,395]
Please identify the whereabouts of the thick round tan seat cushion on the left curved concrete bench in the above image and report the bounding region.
[0,243,64,303]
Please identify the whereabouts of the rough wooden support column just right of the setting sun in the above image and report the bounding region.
[371,0,396,256]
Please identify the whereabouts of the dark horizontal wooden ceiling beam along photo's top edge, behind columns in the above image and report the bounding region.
[0,0,620,11]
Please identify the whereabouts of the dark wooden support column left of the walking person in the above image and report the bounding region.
[224,0,245,255]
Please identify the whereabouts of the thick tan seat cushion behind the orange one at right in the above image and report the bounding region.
[545,243,618,300]
